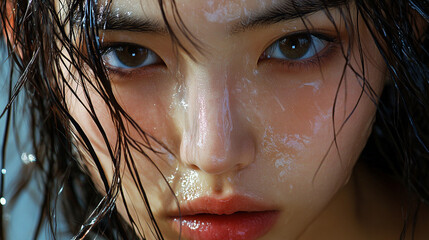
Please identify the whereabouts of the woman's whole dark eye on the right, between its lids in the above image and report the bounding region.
[262,33,331,61]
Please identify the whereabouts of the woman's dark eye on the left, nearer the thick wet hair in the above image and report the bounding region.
[102,43,162,70]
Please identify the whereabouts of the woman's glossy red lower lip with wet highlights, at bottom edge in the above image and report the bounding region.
[173,211,278,240]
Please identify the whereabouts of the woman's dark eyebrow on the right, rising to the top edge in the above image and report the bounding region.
[231,0,349,33]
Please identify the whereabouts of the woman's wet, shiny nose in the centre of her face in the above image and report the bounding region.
[180,67,255,175]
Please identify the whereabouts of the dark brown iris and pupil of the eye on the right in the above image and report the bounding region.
[279,34,311,60]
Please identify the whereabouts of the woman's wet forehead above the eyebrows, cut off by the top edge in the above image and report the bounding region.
[99,0,348,29]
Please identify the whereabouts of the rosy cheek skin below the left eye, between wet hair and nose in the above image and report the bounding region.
[108,74,180,158]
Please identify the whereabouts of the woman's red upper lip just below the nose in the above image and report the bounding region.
[169,195,274,217]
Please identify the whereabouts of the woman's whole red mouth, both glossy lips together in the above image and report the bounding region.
[172,196,278,240]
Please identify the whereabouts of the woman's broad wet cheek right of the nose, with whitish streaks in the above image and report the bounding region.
[235,45,383,202]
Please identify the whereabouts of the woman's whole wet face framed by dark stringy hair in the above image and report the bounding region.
[68,0,383,240]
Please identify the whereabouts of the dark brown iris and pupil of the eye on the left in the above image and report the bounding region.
[116,46,148,67]
